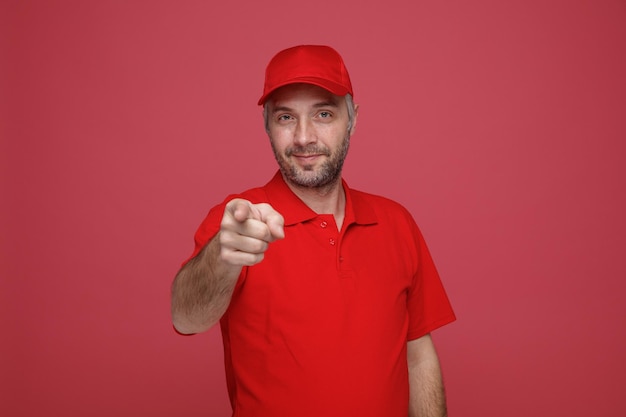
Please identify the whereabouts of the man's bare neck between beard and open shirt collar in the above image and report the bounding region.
[285,177,346,230]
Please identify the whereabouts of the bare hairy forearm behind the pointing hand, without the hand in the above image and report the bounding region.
[171,237,241,334]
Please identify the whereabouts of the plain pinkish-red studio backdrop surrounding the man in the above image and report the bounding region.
[0,0,626,417]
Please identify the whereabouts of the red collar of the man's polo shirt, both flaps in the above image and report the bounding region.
[264,171,378,226]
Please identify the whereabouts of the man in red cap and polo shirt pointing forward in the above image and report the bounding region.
[172,45,455,417]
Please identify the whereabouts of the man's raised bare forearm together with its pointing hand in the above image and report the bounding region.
[171,199,284,334]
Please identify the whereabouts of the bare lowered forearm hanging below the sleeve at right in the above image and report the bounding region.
[407,334,448,417]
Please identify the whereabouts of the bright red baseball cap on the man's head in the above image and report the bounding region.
[254,45,354,105]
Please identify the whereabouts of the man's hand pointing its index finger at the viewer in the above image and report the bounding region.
[219,199,285,266]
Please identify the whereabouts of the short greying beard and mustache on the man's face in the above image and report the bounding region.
[270,135,350,188]
